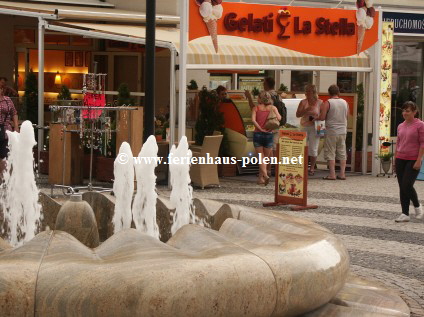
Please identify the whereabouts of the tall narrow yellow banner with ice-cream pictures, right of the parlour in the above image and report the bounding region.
[379,22,393,151]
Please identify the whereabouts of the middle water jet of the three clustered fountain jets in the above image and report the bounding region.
[132,135,159,239]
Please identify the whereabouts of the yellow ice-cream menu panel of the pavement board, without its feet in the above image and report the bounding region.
[277,130,307,203]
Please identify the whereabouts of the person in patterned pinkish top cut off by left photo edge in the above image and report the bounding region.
[0,88,19,180]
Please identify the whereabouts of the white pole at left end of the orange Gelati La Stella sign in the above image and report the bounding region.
[178,0,188,141]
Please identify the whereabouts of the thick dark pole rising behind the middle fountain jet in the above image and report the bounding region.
[143,0,156,142]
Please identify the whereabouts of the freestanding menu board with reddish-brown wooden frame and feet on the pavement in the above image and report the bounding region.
[263,130,318,211]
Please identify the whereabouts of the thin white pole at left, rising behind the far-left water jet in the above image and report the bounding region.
[37,18,45,166]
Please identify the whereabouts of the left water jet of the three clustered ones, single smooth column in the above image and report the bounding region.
[112,142,134,233]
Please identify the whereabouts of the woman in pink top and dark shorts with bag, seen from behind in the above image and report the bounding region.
[252,91,281,186]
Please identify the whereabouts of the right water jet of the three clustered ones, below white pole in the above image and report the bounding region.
[169,136,195,234]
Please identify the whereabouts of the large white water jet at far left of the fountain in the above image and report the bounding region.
[0,121,41,246]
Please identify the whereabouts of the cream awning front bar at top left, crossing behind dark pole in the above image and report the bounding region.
[0,1,180,24]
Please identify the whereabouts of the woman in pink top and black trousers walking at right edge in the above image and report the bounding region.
[395,101,424,222]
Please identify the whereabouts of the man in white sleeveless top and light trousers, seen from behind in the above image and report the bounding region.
[318,85,349,180]
